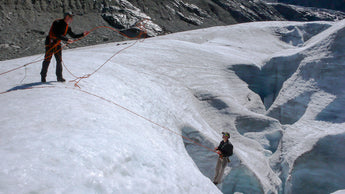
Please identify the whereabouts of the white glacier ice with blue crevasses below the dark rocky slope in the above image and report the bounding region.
[0,20,345,194]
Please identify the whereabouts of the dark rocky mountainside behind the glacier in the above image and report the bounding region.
[0,0,345,60]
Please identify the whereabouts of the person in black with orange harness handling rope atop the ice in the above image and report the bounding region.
[41,12,88,82]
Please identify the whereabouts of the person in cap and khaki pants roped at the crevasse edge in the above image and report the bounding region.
[213,132,233,185]
